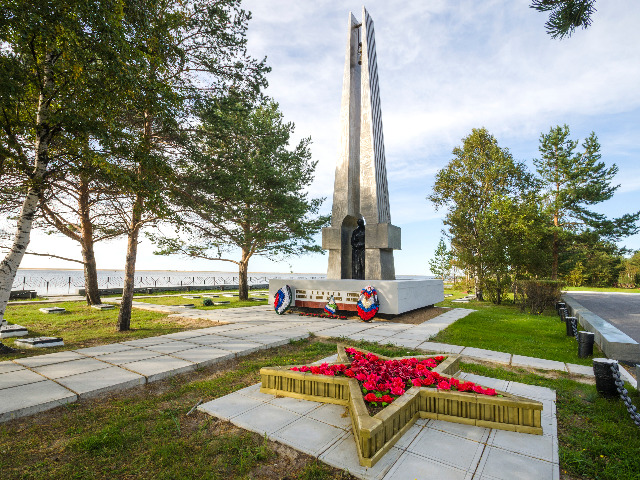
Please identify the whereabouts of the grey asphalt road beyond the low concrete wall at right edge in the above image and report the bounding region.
[567,292,640,343]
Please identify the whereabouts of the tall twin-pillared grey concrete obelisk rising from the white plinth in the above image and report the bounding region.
[322,7,400,280]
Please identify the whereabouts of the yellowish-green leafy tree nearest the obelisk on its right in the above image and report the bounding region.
[428,128,545,303]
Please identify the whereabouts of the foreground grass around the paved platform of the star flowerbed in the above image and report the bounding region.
[0,338,640,480]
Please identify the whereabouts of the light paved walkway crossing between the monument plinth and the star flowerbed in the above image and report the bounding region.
[0,302,593,422]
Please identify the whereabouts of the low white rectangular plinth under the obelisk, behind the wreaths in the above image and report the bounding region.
[269,278,444,315]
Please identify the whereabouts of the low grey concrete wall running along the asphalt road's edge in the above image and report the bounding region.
[562,294,640,363]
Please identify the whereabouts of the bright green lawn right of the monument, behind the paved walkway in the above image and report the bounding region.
[431,292,601,365]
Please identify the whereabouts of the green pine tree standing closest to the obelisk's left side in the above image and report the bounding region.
[153,92,329,296]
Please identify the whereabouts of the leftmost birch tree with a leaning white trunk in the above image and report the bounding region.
[0,0,127,344]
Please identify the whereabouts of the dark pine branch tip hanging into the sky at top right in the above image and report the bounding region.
[530,0,596,39]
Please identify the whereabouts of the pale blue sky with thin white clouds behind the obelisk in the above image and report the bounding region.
[12,0,640,275]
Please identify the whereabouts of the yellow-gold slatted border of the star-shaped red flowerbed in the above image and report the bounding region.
[260,345,542,467]
